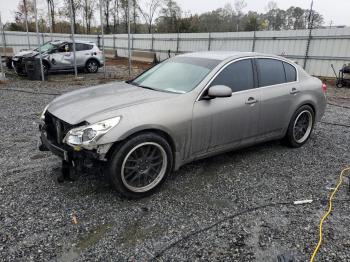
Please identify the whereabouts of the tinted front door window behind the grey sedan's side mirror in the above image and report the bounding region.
[211,59,254,92]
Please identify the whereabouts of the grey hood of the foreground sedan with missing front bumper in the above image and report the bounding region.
[48,82,175,125]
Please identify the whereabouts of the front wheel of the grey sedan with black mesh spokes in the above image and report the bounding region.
[108,133,173,199]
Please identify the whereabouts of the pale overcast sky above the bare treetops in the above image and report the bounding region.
[0,0,350,26]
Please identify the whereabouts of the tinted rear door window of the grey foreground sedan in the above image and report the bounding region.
[257,58,286,87]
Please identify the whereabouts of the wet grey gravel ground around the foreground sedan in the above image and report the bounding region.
[0,68,350,261]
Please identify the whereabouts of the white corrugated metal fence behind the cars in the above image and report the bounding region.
[0,27,350,77]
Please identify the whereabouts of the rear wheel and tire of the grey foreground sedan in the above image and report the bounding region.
[285,105,315,148]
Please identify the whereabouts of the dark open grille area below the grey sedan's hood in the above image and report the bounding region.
[45,112,75,146]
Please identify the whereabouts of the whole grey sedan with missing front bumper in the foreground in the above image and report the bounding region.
[40,52,326,198]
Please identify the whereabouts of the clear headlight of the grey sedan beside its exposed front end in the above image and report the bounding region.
[63,116,121,146]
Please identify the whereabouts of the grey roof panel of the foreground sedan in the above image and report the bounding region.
[180,51,284,61]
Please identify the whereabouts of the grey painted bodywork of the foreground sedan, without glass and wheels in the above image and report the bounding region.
[48,52,326,169]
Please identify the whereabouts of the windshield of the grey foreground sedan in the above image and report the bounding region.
[131,57,220,94]
